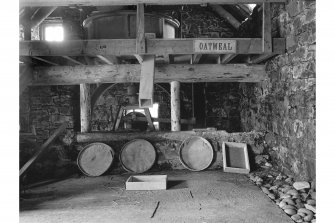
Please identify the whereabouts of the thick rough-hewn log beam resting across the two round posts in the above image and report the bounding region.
[32,64,267,85]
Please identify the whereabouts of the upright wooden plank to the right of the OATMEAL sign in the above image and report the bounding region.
[262,3,272,53]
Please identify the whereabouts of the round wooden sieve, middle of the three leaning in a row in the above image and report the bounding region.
[120,139,156,173]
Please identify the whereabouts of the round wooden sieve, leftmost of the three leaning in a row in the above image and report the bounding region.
[77,142,114,177]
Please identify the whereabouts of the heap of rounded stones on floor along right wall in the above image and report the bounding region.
[249,169,316,223]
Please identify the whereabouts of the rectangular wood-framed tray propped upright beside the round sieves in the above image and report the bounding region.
[222,142,250,174]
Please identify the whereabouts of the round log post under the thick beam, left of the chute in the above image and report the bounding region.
[80,84,91,132]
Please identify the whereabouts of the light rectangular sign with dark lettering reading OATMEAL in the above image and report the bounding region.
[193,39,236,53]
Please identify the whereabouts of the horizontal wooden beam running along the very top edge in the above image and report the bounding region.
[20,0,286,7]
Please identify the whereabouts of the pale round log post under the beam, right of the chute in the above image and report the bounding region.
[170,81,181,132]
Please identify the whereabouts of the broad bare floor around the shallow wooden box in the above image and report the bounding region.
[20,171,293,223]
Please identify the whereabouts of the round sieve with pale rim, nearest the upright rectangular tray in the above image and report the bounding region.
[179,136,214,171]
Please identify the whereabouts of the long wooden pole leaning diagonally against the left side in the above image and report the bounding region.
[20,122,68,176]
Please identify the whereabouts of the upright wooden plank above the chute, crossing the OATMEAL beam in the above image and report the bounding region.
[136,4,146,54]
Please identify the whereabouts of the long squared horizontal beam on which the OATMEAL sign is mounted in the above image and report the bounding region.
[20,38,285,56]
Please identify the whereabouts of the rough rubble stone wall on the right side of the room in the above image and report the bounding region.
[240,0,316,179]
